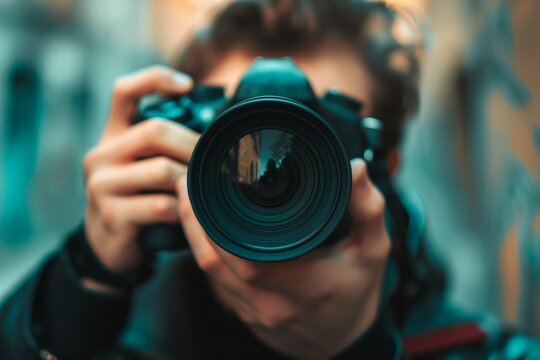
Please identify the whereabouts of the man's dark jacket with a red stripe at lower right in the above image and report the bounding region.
[0,191,540,360]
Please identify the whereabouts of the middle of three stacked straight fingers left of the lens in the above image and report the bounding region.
[87,157,187,195]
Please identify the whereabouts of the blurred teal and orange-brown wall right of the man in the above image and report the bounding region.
[397,0,540,336]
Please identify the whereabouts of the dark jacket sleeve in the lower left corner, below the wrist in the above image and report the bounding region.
[0,232,130,359]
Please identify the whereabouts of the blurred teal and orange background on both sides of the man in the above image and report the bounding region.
[0,0,540,336]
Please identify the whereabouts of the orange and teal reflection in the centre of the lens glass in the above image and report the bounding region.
[221,129,299,207]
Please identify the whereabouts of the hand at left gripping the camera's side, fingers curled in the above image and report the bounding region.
[82,67,199,291]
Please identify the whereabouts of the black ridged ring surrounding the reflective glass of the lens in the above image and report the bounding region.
[188,96,351,261]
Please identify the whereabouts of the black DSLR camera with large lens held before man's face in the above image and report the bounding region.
[135,58,387,261]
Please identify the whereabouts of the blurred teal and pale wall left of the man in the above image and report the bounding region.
[0,0,162,296]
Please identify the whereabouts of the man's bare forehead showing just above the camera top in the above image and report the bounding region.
[199,43,374,115]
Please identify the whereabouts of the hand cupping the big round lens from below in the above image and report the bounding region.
[178,159,390,359]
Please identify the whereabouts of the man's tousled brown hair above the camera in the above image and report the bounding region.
[175,0,418,148]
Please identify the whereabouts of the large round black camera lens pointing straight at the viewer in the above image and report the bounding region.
[188,96,351,261]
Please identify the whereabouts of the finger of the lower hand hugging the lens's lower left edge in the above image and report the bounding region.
[177,177,223,277]
